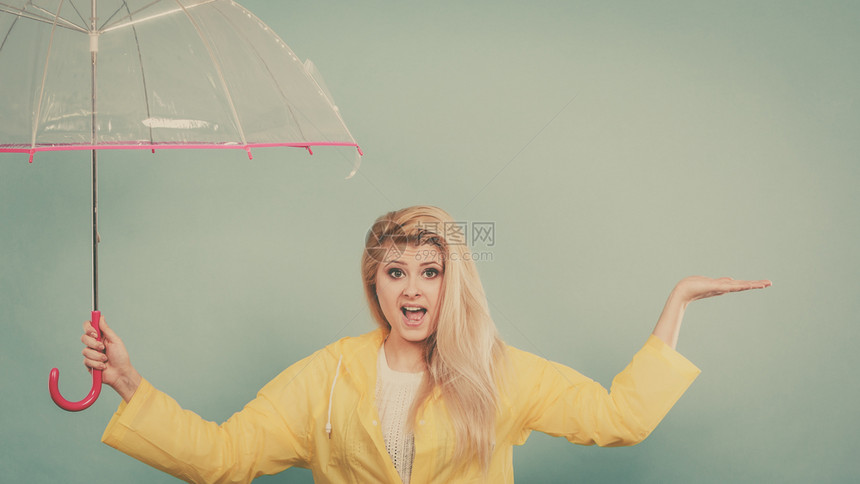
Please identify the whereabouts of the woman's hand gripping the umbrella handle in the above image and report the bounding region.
[81,316,141,402]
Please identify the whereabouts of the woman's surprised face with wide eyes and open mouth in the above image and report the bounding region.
[376,244,443,344]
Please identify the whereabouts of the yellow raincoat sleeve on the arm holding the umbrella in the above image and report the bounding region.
[102,355,324,482]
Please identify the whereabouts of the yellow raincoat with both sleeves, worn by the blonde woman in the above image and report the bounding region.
[102,330,699,484]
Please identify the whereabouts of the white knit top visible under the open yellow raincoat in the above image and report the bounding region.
[376,344,424,484]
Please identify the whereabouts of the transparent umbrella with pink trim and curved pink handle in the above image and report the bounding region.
[0,0,361,411]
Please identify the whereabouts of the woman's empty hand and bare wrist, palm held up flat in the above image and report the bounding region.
[652,276,772,349]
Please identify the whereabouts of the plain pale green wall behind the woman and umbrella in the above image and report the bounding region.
[0,0,860,483]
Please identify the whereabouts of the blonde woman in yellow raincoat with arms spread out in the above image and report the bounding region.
[82,206,770,484]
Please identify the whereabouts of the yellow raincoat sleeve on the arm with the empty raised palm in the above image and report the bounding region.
[511,336,700,447]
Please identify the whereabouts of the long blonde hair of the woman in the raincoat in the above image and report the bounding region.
[361,206,504,472]
